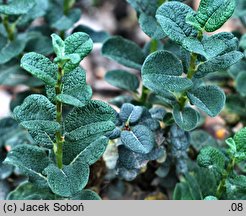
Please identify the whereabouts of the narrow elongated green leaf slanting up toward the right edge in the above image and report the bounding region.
[194,51,244,78]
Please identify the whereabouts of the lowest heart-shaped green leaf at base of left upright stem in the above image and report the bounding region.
[44,164,89,197]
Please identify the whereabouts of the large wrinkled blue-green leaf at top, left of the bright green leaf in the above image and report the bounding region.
[156,2,196,44]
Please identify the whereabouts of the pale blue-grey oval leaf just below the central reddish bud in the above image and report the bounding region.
[120,125,155,154]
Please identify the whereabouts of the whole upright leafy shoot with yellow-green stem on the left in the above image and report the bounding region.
[4,32,115,199]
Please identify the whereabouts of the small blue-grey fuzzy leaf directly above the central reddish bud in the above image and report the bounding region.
[119,103,143,124]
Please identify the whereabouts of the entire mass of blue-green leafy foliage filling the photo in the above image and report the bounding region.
[0,0,246,200]
